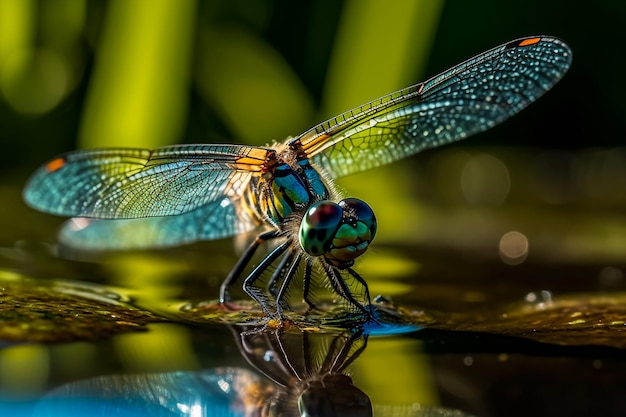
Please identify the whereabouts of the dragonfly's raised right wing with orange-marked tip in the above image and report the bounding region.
[294,36,572,177]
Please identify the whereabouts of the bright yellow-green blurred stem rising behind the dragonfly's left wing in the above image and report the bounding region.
[79,0,196,147]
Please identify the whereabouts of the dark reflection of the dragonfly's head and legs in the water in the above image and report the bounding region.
[235,329,372,416]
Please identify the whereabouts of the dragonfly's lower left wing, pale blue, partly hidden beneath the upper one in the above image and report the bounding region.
[59,197,258,251]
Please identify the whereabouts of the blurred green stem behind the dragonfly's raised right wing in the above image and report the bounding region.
[322,0,444,117]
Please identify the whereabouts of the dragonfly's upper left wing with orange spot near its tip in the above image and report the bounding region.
[24,145,274,219]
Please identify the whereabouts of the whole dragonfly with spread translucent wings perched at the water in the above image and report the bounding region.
[23,36,572,320]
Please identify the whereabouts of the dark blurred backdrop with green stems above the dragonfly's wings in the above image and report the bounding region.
[0,0,626,176]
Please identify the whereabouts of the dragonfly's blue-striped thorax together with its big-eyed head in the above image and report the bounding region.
[252,146,376,269]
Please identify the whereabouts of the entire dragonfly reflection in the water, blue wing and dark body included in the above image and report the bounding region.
[34,328,467,417]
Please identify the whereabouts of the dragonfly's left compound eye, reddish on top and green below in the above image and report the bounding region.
[299,201,343,256]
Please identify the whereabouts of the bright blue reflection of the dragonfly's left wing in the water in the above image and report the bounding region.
[33,367,263,417]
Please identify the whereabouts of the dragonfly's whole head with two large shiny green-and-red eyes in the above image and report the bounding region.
[299,198,376,269]
